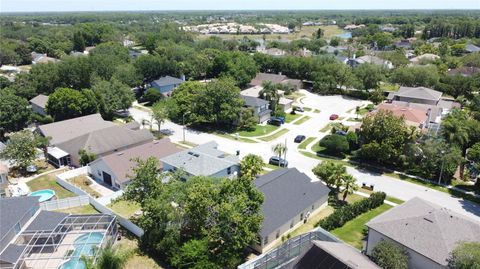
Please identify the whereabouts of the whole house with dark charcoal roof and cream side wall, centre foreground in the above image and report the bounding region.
[252,168,330,252]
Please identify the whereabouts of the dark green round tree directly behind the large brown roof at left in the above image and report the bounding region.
[46,88,98,121]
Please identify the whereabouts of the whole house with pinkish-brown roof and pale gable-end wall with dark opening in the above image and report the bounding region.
[88,138,180,189]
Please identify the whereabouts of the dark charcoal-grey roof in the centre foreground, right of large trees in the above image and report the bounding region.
[255,168,330,238]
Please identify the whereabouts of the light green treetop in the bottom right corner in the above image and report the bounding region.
[448,242,480,269]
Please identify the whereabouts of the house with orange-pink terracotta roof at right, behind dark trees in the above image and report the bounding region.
[369,103,435,130]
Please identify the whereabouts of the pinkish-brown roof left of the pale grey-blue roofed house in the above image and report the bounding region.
[90,138,180,183]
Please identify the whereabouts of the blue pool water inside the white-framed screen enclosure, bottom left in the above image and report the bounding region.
[61,232,103,269]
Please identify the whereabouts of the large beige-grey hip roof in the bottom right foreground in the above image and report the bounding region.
[366,197,480,265]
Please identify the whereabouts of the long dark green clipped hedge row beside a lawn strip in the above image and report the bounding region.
[317,192,387,231]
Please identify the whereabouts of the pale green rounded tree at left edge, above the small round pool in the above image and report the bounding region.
[0,130,37,170]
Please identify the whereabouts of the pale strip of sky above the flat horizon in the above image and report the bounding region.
[0,0,480,13]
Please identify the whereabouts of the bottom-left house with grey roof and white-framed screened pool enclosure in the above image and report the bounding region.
[0,196,117,269]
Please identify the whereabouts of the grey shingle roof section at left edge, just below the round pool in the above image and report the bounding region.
[0,196,39,239]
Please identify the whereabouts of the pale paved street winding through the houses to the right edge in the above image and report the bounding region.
[130,91,480,221]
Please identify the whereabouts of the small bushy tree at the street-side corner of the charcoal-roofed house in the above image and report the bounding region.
[312,161,347,193]
